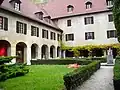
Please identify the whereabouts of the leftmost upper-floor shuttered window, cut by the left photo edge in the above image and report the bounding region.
[0,16,8,31]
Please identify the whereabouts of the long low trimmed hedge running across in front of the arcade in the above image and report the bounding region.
[31,60,92,65]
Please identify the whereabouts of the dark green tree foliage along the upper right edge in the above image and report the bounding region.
[113,0,120,42]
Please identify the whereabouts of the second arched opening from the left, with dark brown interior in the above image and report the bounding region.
[16,42,27,63]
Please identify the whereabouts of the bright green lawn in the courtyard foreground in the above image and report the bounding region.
[0,65,74,90]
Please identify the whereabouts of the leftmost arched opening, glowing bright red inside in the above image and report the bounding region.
[0,40,11,56]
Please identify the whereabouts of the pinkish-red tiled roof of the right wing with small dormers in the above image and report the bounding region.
[44,0,111,18]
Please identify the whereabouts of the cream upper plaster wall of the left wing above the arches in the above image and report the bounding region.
[0,12,60,47]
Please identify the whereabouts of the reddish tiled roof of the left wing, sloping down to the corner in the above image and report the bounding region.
[0,0,62,31]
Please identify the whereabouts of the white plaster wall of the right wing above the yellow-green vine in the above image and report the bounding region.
[57,12,118,46]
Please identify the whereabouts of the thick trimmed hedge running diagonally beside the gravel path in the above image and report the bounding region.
[63,61,100,90]
